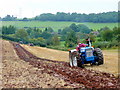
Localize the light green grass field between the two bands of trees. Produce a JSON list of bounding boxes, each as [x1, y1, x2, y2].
[[0, 21, 118, 31]]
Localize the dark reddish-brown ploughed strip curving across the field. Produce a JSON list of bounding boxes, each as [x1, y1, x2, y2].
[[11, 42, 120, 88]]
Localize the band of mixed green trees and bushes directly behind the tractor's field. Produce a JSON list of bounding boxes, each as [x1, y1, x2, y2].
[[1, 23, 120, 49]]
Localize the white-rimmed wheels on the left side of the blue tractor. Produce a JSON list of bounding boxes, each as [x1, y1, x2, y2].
[[69, 51, 83, 67]]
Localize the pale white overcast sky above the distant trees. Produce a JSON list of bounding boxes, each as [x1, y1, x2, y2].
[[0, 0, 119, 18]]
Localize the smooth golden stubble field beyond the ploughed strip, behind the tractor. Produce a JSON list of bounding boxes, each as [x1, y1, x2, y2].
[[22, 45, 119, 76]]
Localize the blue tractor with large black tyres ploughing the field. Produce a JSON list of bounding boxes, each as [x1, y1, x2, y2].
[[69, 41, 104, 67]]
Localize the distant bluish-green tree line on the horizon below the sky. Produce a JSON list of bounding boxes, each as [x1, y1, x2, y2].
[[0, 11, 118, 23]]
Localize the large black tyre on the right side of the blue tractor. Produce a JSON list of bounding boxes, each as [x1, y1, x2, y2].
[[93, 48, 104, 65]]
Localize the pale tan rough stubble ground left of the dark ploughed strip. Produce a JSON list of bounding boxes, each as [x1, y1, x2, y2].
[[0, 40, 72, 88]]
